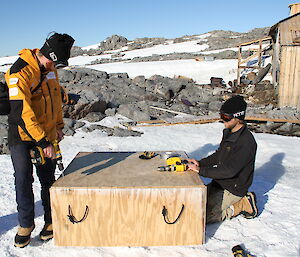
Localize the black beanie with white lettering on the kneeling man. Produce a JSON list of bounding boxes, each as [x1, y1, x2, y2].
[[220, 95, 247, 120]]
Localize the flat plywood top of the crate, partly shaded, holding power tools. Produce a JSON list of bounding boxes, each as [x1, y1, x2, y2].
[[52, 152, 204, 189]]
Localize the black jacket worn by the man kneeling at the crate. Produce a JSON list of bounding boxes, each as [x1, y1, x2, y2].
[[199, 125, 257, 196]]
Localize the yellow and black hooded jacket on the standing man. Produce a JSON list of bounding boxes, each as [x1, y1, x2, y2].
[[5, 49, 64, 148]]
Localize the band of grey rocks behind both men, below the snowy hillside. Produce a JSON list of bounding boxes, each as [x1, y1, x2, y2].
[[0, 65, 300, 153]]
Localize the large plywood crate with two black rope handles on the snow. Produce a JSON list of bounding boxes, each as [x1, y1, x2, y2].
[[50, 152, 206, 246]]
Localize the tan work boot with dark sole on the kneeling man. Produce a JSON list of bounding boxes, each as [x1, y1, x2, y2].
[[233, 192, 258, 219]]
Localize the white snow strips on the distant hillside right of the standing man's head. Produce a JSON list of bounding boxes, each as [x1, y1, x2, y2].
[[69, 34, 237, 84]]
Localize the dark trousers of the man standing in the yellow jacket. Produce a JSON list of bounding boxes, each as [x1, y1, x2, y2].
[[10, 144, 55, 228]]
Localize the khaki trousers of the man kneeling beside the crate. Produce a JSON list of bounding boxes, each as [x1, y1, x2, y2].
[[206, 183, 242, 224]]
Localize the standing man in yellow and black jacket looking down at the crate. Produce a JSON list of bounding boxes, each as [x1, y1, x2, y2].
[[5, 33, 74, 247]]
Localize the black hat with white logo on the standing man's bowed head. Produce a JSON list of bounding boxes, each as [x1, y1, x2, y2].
[[40, 33, 75, 67]]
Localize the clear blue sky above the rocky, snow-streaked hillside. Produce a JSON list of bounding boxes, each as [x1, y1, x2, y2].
[[0, 0, 297, 56]]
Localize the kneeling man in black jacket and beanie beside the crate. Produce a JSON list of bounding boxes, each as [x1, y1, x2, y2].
[[188, 95, 258, 223]]
